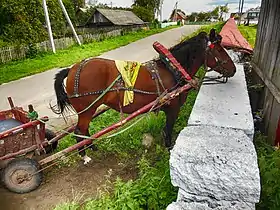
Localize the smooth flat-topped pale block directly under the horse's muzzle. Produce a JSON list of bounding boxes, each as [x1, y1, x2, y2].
[[188, 64, 254, 140]]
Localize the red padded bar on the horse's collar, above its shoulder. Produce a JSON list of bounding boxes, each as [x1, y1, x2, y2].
[[153, 42, 192, 81]]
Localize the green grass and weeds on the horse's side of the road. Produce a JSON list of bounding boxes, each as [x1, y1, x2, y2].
[[52, 24, 224, 210]]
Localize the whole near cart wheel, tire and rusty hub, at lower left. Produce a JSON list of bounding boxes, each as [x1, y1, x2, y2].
[[2, 158, 43, 193]]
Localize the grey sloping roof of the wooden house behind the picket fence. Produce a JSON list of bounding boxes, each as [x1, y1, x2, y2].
[[95, 8, 144, 25]]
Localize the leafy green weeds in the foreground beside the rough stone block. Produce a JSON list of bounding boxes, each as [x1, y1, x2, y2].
[[80, 146, 177, 210]]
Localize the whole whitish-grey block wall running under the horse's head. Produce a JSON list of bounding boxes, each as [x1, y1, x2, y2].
[[167, 55, 260, 210]]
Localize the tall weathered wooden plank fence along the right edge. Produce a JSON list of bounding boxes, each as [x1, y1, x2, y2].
[[252, 0, 280, 144]]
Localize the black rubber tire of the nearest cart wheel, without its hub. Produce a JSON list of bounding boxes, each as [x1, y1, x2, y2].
[[2, 158, 43, 194]]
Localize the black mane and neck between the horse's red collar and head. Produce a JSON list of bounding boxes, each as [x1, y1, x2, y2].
[[169, 32, 208, 73]]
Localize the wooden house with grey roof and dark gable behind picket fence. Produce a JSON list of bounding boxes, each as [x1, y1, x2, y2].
[[83, 8, 144, 27]]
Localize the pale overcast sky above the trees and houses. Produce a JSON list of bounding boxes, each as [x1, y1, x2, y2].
[[98, 0, 261, 19]]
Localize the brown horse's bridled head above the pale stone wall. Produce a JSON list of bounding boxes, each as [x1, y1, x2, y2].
[[205, 28, 236, 78]]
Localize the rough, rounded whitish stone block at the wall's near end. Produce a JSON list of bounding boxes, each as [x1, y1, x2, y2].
[[170, 125, 260, 206]]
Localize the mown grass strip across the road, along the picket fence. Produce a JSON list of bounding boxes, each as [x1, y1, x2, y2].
[[0, 26, 177, 84]]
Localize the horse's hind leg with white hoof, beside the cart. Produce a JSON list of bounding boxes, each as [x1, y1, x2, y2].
[[74, 112, 94, 164]]
